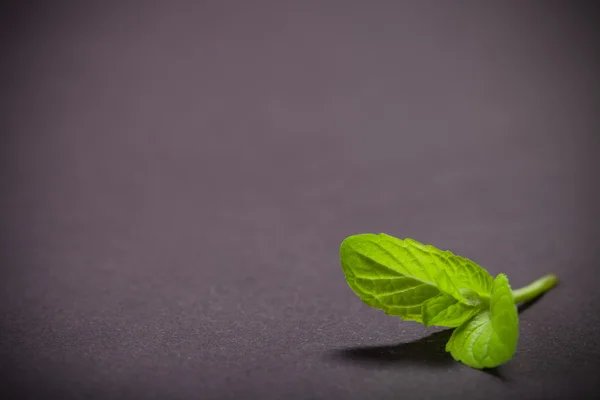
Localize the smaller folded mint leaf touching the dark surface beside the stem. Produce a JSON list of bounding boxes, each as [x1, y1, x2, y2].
[[446, 274, 519, 369]]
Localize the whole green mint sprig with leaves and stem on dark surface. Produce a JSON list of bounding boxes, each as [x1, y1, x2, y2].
[[340, 233, 558, 369]]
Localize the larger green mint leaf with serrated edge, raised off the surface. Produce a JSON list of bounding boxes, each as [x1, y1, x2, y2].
[[340, 234, 493, 326]]
